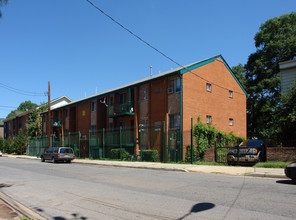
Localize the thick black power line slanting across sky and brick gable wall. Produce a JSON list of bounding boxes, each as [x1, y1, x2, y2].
[[86, 0, 245, 95]]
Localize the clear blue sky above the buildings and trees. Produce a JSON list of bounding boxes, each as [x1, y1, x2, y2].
[[0, 0, 296, 118]]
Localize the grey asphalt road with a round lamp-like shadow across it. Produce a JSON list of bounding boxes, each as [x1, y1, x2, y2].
[[0, 157, 296, 220]]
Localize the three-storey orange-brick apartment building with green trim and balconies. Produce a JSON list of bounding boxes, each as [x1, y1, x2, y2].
[[43, 55, 247, 162]]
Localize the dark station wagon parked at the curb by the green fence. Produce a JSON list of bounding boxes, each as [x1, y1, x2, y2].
[[40, 147, 75, 163]]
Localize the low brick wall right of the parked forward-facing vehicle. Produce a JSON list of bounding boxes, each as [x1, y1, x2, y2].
[[266, 147, 296, 162]]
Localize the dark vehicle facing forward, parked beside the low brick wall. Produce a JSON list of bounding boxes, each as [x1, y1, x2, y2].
[[227, 139, 275, 165]]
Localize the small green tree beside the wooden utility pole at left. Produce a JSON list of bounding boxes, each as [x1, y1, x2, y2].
[[26, 104, 48, 137]]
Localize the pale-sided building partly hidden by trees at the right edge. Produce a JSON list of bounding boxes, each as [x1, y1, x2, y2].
[[279, 59, 296, 93]]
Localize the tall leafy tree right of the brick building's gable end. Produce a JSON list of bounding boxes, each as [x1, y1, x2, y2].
[[245, 12, 296, 138]]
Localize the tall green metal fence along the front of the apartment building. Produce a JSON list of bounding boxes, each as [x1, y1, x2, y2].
[[28, 122, 204, 162]]
